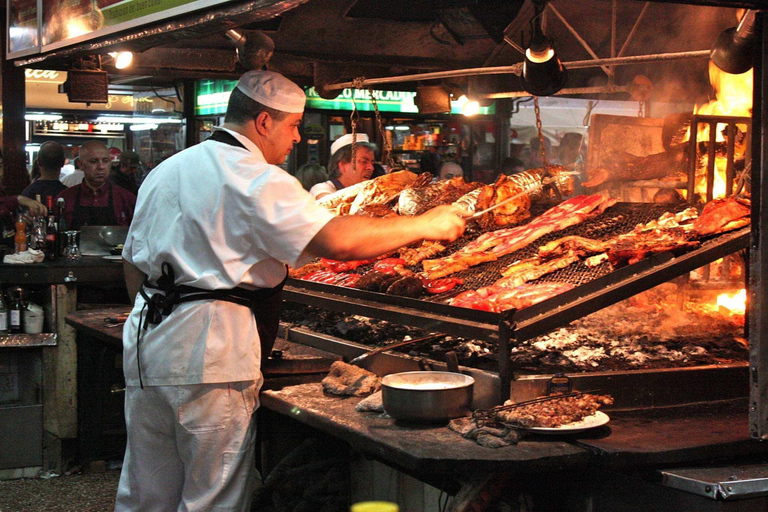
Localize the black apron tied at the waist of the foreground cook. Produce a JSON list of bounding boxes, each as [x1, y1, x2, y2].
[[136, 262, 288, 388]]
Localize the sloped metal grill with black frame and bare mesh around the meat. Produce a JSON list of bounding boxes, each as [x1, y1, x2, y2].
[[284, 203, 749, 399]]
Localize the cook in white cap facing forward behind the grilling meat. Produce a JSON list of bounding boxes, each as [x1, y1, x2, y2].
[[309, 133, 376, 199]]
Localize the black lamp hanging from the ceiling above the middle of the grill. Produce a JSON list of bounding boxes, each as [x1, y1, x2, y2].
[[521, 0, 567, 96]]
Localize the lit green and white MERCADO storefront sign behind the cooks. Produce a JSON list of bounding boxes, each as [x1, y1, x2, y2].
[[195, 80, 496, 115]]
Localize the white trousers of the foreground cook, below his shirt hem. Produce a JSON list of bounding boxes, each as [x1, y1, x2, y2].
[[115, 381, 260, 512]]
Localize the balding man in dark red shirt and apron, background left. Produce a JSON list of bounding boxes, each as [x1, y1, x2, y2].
[[56, 140, 136, 229]]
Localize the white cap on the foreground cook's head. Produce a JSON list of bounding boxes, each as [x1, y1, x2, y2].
[[237, 70, 307, 114]]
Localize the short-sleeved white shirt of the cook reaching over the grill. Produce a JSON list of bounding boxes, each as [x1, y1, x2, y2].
[[123, 130, 333, 386]]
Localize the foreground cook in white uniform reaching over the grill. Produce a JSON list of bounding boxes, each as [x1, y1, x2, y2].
[[115, 71, 466, 511]]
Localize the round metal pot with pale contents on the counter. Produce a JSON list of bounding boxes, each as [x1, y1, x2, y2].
[[381, 372, 475, 422]]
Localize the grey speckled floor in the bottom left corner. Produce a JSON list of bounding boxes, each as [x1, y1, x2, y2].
[[0, 470, 120, 512]]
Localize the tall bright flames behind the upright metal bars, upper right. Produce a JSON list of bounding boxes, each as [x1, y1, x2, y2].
[[693, 61, 753, 198]]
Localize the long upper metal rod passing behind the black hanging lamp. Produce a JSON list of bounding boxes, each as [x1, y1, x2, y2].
[[325, 50, 709, 91]]
